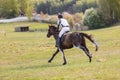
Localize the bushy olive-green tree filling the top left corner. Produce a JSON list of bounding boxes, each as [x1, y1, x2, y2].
[[0, 0, 19, 18]]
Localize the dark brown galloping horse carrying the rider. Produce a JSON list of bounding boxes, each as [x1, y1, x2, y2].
[[47, 25, 98, 65]]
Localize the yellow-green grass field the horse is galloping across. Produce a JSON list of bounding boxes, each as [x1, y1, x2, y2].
[[0, 22, 120, 80]]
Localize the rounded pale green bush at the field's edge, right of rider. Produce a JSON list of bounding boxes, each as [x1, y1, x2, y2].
[[83, 8, 105, 29]]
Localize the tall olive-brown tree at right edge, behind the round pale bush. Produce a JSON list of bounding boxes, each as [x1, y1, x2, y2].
[[98, 0, 120, 25]]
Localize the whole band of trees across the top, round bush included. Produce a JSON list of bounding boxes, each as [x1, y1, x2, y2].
[[0, 0, 120, 29]]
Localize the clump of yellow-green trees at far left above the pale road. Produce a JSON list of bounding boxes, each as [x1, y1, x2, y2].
[[0, 0, 32, 18]]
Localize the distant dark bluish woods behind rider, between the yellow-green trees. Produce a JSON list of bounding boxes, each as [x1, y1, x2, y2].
[[35, 0, 98, 14]]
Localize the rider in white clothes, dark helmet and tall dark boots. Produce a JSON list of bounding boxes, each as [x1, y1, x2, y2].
[[56, 13, 70, 47]]
